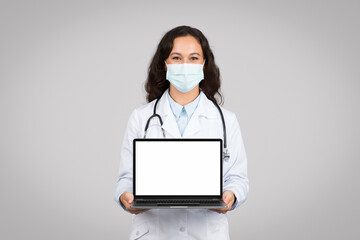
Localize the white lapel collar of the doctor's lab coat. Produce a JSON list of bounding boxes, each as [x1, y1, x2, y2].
[[156, 89, 220, 138]]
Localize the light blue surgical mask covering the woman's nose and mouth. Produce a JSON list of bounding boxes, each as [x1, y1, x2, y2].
[[165, 61, 205, 93]]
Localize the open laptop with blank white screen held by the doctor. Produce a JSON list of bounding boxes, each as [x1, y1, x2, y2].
[[131, 138, 226, 209]]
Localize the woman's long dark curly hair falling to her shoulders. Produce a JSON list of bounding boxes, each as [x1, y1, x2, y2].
[[145, 26, 223, 104]]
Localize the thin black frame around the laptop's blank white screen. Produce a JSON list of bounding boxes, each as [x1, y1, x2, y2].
[[133, 138, 223, 200]]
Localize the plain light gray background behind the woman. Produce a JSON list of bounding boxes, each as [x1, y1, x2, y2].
[[0, 0, 360, 239]]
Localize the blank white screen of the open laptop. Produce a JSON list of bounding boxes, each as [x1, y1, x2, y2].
[[135, 140, 221, 196]]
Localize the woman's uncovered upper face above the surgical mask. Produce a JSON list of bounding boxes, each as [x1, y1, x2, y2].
[[165, 36, 204, 64]]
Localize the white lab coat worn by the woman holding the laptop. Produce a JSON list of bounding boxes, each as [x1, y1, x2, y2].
[[115, 90, 249, 240]]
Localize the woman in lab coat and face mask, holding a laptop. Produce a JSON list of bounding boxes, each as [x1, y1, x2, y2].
[[115, 26, 249, 240]]
